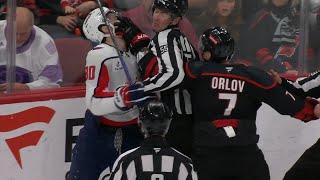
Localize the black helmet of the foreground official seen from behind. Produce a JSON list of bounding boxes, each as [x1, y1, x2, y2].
[[138, 100, 172, 137]]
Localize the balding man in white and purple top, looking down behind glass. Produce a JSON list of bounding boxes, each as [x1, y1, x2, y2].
[[0, 7, 62, 91]]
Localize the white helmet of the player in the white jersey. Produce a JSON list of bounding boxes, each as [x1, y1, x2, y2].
[[82, 7, 116, 43]]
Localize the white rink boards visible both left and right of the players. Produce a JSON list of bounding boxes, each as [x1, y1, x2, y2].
[[0, 89, 320, 180]]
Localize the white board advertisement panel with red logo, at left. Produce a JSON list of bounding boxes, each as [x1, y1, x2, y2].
[[0, 98, 85, 180]]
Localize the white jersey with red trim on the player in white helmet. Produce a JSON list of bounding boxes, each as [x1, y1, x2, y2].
[[85, 44, 139, 127]]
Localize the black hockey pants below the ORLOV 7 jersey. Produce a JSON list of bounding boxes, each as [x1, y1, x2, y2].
[[193, 145, 270, 180]]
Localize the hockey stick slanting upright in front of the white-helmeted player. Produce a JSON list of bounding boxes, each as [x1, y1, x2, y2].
[[96, 0, 133, 84]]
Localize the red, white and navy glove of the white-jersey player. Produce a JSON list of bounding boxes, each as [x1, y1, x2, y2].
[[114, 82, 154, 110]]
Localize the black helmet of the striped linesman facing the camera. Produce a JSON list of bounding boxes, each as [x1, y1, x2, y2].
[[152, 0, 188, 17]]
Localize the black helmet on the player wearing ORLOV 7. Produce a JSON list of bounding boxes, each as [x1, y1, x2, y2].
[[199, 27, 234, 63]]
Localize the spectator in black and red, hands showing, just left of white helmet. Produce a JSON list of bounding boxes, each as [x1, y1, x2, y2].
[[36, 0, 98, 38]]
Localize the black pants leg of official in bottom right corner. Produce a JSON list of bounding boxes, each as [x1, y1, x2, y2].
[[283, 139, 320, 180]]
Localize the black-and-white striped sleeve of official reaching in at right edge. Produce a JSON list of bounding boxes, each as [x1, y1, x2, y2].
[[282, 71, 320, 98]]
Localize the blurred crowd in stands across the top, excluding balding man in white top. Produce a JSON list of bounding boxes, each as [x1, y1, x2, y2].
[[0, 0, 320, 92]]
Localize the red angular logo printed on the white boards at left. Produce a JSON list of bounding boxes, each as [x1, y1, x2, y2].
[[0, 106, 55, 169]]
